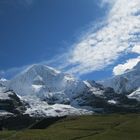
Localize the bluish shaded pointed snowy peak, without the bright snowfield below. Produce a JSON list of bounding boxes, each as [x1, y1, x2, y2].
[[7, 65, 86, 104]]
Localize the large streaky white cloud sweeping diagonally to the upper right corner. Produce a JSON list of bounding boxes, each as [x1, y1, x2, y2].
[[56, 0, 140, 75]]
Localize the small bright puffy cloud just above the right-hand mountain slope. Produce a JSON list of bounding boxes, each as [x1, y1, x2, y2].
[[113, 57, 140, 75]]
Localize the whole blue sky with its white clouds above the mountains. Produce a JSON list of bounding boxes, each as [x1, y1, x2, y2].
[[0, 0, 140, 80]]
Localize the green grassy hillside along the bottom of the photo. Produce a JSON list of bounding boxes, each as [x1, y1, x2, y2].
[[0, 114, 140, 140]]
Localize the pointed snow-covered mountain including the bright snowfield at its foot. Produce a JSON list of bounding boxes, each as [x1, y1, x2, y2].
[[6, 65, 100, 116]]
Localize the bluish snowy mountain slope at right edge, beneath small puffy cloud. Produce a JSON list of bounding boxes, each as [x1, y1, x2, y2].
[[100, 62, 140, 94]]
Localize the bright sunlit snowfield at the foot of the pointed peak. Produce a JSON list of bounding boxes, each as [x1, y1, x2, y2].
[[22, 96, 93, 117]]
